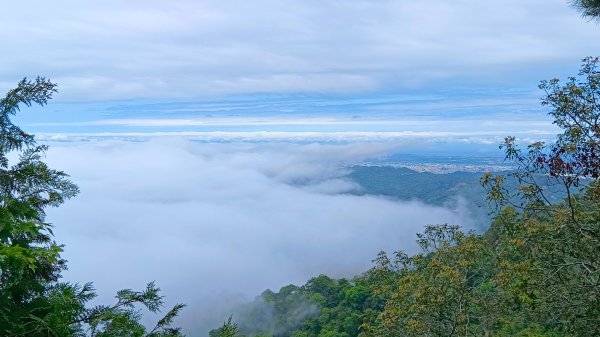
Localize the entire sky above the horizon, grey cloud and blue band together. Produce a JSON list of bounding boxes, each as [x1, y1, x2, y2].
[[0, 0, 600, 142]]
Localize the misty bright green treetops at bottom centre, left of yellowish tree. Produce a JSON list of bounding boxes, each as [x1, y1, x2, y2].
[[211, 275, 383, 337]]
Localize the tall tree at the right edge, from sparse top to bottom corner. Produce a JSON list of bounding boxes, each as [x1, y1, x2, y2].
[[482, 57, 600, 336]]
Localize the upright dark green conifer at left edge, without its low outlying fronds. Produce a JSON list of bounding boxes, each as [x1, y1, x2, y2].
[[0, 78, 80, 335]]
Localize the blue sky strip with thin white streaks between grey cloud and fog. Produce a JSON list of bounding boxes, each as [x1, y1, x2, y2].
[[18, 90, 557, 154]]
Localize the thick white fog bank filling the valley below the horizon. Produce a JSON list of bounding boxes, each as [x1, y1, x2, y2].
[[42, 139, 470, 336]]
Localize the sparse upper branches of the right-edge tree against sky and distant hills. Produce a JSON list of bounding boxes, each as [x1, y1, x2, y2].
[[482, 57, 600, 211]]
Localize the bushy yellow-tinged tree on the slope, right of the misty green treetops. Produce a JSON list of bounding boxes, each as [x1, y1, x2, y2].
[[368, 225, 500, 337]]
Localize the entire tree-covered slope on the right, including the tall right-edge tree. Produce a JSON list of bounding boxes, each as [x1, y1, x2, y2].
[[220, 58, 600, 337]]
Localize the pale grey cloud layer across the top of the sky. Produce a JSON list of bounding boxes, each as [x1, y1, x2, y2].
[[0, 0, 600, 100]]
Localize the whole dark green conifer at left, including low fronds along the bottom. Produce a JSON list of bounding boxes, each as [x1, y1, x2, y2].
[[0, 78, 183, 337]]
